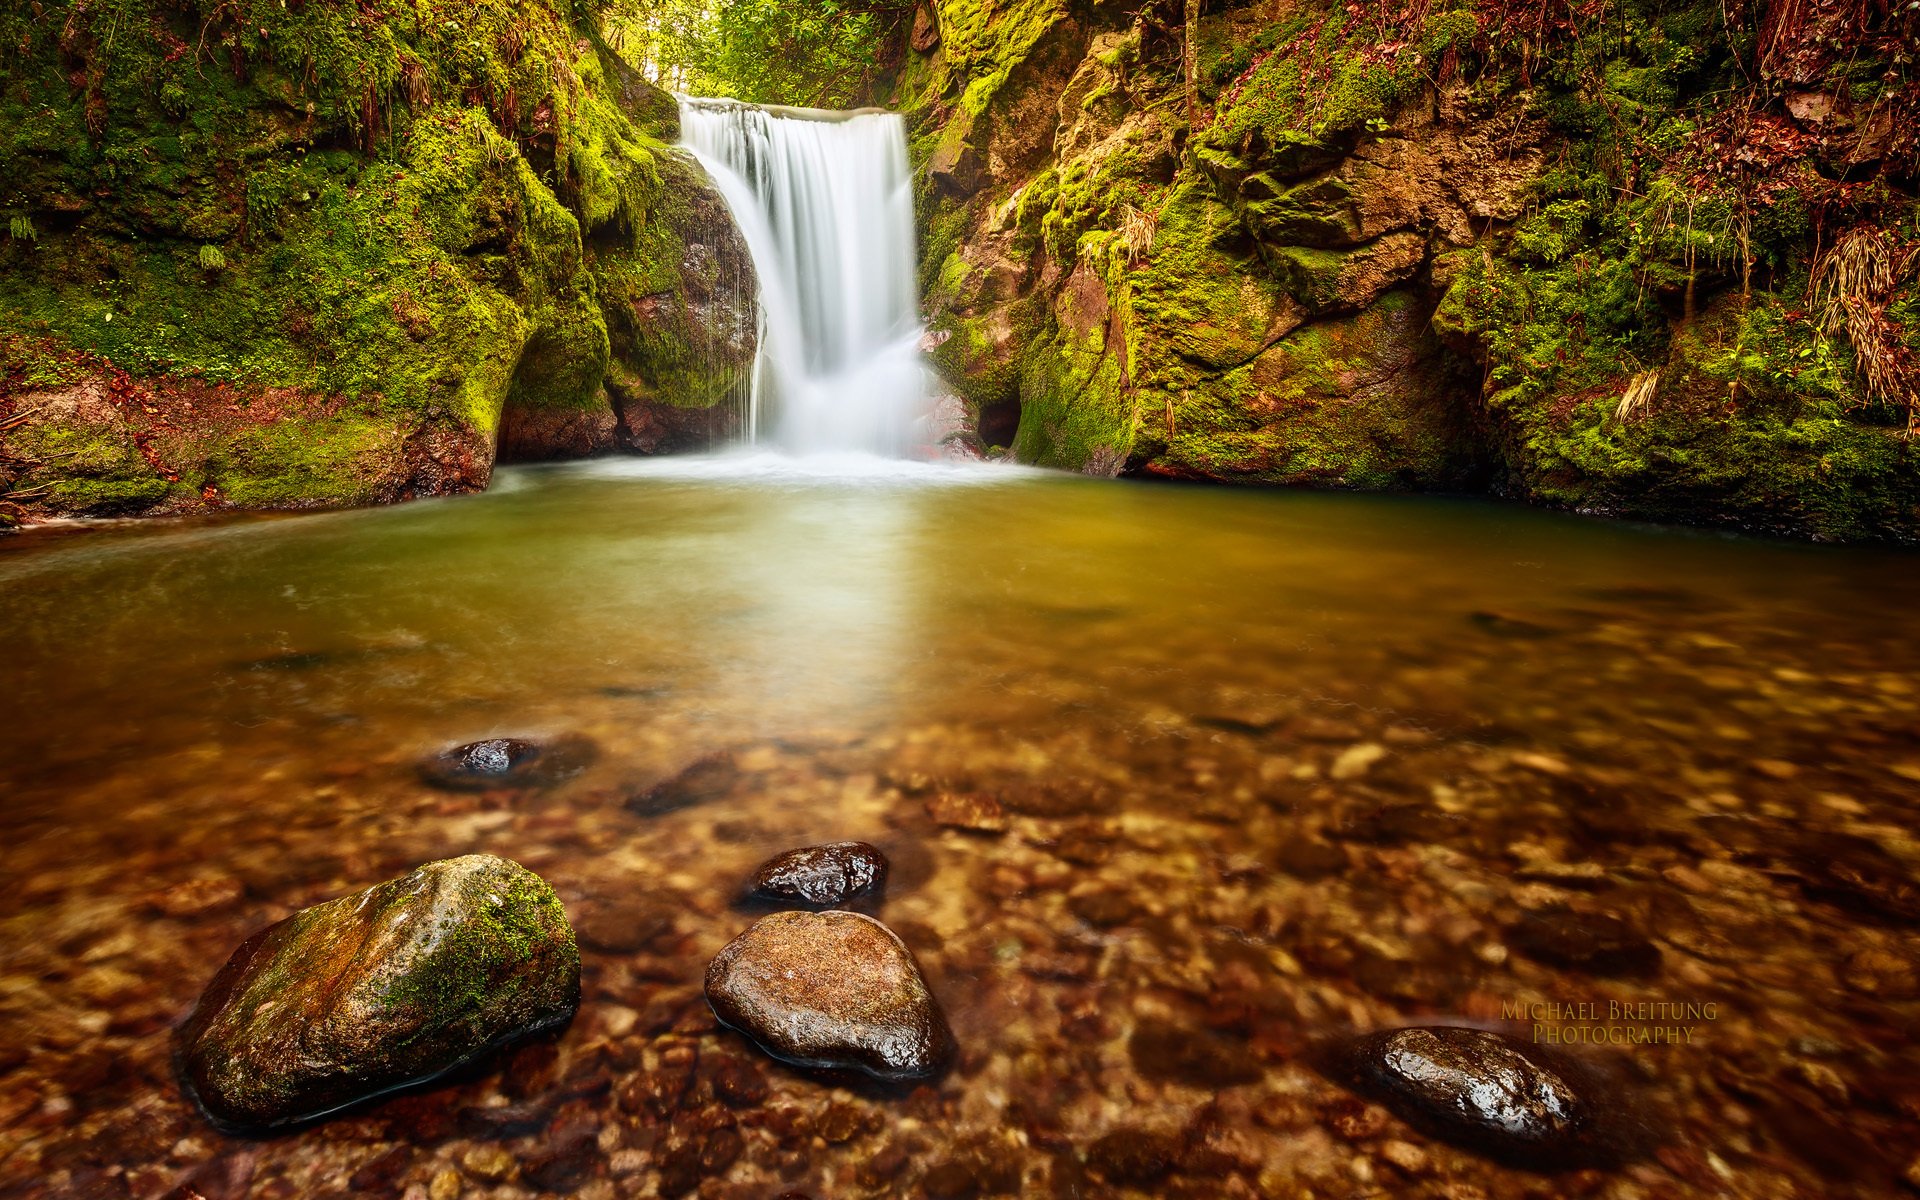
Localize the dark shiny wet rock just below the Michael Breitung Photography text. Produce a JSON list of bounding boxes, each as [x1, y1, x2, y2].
[[1348, 1025, 1594, 1167]]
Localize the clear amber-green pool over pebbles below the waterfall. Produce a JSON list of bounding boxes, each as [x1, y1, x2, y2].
[[0, 457, 1920, 1200]]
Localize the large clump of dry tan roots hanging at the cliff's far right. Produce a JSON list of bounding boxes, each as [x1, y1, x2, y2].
[[1809, 225, 1920, 436]]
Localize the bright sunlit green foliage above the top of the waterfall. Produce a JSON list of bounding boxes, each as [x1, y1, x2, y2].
[[607, 0, 914, 108]]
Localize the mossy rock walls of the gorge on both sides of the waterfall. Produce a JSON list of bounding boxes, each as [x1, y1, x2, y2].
[[0, 0, 1920, 541]]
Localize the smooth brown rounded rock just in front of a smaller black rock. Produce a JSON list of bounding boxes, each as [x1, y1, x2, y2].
[[707, 910, 954, 1079]]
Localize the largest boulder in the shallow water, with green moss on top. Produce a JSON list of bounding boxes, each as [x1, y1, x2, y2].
[[177, 854, 580, 1129]]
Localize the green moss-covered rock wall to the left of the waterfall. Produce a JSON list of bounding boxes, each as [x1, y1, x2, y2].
[[0, 0, 755, 513]]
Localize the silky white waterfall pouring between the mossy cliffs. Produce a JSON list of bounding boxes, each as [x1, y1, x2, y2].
[[680, 98, 927, 455]]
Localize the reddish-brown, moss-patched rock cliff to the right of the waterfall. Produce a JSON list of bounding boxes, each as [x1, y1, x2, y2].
[[899, 0, 1920, 540]]
